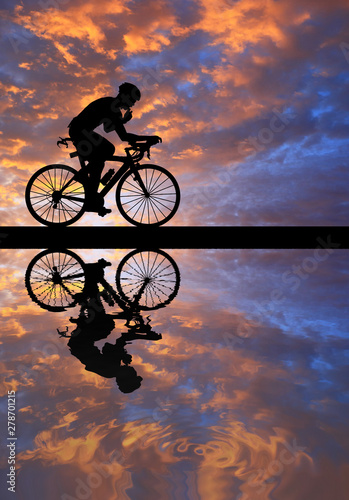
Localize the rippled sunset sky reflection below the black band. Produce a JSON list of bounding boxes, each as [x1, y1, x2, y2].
[[0, 249, 349, 500]]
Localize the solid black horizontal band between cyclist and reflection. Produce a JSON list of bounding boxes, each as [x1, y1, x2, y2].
[[0, 226, 349, 249]]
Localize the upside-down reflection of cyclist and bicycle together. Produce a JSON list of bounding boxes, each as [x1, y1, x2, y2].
[[25, 249, 180, 392]]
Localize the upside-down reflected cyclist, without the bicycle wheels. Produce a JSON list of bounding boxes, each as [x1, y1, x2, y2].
[[64, 259, 162, 393]]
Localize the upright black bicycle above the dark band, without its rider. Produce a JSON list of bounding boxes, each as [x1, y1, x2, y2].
[[25, 138, 180, 226]]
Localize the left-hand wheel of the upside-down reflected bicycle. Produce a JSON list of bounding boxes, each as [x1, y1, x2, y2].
[[25, 250, 85, 311]]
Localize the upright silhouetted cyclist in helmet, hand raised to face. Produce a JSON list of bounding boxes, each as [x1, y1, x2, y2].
[[68, 82, 161, 217]]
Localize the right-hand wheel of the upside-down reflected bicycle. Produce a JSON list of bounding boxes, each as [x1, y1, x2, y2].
[[116, 250, 180, 310]]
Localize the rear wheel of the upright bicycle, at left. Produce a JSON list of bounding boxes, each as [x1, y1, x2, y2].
[[25, 165, 85, 226]]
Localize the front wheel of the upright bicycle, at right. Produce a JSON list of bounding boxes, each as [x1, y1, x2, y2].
[[116, 165, 180, 226]]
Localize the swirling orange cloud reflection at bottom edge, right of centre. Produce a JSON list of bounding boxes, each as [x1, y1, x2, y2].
[[194, 420, 313, 500]]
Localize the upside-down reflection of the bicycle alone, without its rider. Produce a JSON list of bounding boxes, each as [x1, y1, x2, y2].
[[25, 250, 180, 312]]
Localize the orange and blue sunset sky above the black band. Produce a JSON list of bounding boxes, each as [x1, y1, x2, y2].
[[0, 0, 349, 226]]
